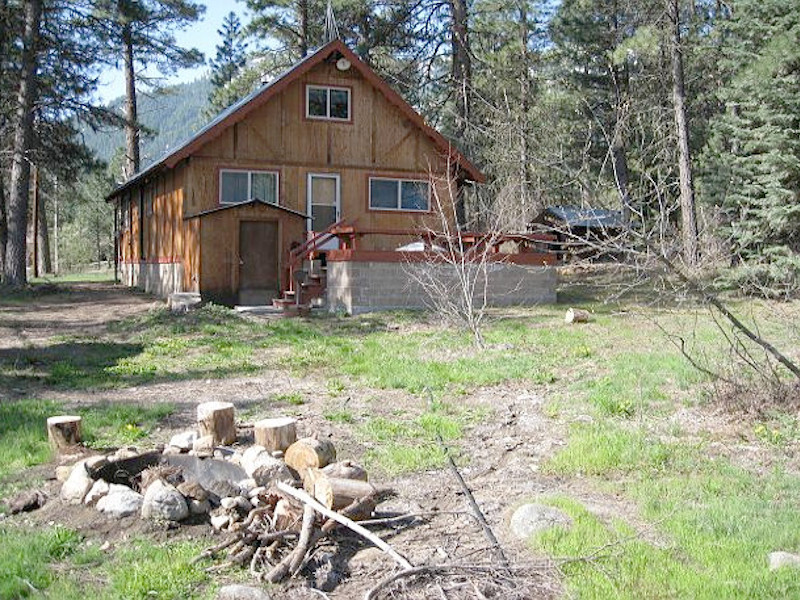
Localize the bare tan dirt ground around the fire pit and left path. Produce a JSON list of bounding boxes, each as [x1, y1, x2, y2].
[[0, 285, 580, 598]]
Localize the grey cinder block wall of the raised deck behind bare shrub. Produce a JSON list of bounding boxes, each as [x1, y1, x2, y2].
[[327, 261, 557, 314]]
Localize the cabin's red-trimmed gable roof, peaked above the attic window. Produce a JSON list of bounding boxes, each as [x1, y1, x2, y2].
[[106, 40, 486, 200]]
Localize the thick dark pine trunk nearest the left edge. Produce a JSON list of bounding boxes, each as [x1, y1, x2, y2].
[[3, 0, 42, 285]]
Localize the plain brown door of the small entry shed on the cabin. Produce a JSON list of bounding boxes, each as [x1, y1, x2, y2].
[[239, 221, 280, 305]]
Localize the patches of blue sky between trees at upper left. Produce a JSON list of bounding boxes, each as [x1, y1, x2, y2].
[[97, 0, 249, 101]]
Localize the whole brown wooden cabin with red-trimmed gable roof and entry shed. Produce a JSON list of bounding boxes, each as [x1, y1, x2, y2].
[[108, 40, 484, 304]]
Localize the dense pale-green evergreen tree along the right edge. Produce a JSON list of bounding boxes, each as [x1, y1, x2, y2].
[[704, 0, 800, 294]]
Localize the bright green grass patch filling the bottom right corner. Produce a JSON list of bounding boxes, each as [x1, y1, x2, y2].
[[535, 424, 800, 600]]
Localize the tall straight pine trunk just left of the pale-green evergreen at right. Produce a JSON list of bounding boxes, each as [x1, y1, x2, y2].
[[668, 0, 698, 265]]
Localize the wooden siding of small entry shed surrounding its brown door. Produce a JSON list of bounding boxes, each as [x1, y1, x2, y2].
[[195, 204, 305, 304]]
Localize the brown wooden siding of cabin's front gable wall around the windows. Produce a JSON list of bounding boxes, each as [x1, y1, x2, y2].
[[186, 62, 455, 250]]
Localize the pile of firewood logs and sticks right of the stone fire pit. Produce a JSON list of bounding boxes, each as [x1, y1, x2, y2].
[[198, 437, 394, 583]]
